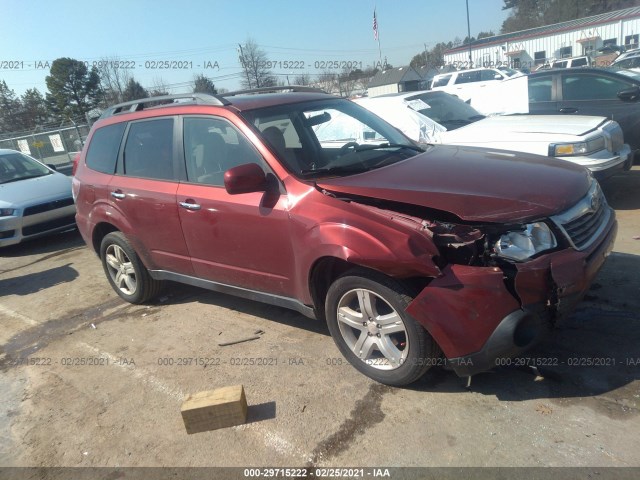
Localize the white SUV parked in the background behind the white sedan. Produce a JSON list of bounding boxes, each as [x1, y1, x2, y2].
[[431, 68, 518, 101]]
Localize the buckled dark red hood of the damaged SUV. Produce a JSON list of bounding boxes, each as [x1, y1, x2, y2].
[[317, 145, 591, 223]]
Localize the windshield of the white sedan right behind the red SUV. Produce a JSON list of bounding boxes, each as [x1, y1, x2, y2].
[[406, 92, 484, 130]]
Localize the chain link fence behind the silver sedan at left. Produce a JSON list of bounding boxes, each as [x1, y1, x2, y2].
[[0, 125, 90, 167]]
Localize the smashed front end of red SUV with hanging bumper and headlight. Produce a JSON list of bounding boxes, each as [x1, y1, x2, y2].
[[407, 182, 617, 376]]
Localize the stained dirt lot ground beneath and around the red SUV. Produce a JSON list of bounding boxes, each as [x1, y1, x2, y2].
[[0, 166, 640, 474]]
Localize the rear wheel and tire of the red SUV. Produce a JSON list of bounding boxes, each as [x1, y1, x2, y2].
[[100, 232, 162, 304]]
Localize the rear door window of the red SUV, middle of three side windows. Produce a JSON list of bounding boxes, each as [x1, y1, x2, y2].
[[123, 118, 175, 180]]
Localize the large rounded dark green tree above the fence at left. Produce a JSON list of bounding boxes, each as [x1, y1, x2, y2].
[[45, 58, 102, 117]]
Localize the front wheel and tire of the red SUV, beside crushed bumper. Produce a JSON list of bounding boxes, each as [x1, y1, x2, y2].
[[325, 270, 440, 386]]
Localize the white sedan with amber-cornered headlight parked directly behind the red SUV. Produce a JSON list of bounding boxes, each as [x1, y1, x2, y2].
[[355, 91, 633, 180]]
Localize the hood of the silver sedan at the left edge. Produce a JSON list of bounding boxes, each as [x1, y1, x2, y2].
[[0, 173, 71, 207]]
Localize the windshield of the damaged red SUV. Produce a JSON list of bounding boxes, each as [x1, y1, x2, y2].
[[243, 99, 422, 178]]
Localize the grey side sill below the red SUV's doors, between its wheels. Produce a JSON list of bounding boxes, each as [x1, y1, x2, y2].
[[149, 270, 316, 319]]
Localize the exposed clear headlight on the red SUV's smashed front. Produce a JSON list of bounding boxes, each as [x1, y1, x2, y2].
[[494, 222, 557, 261]]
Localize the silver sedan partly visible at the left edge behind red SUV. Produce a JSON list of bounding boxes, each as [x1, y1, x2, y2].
[[0, 149, 76, 247]]
